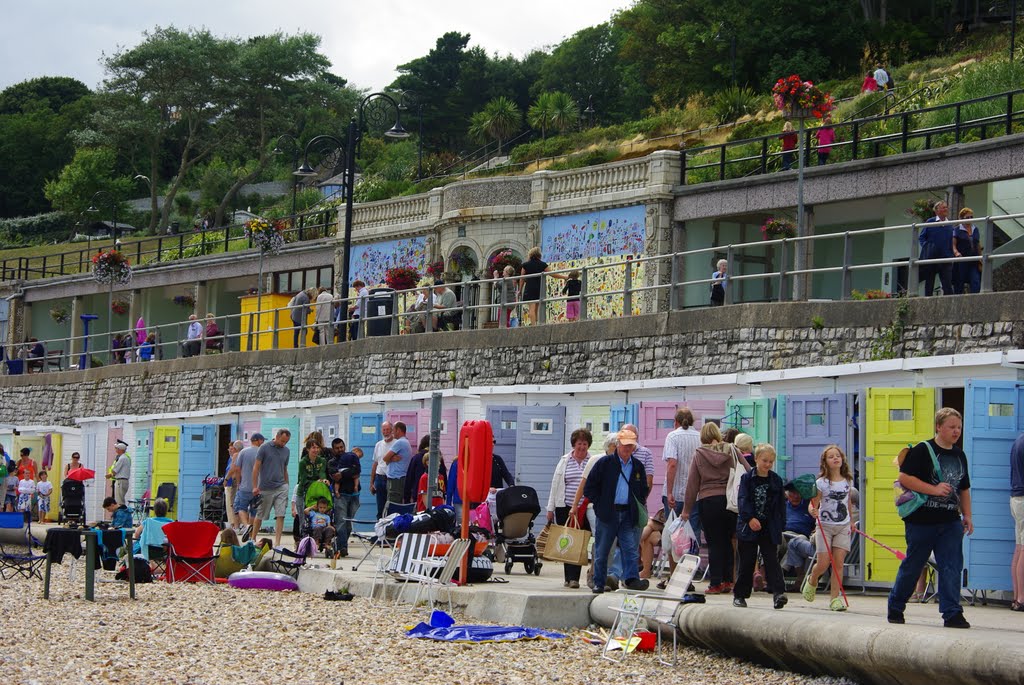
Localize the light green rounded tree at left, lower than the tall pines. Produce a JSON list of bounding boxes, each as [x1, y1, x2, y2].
[[44, 147, 132, 219]]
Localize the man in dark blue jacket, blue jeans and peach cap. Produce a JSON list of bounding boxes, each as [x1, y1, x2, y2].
[[584, 429, 649, 594]]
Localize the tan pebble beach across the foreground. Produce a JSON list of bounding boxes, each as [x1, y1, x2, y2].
[[0, 564, 864, 685]]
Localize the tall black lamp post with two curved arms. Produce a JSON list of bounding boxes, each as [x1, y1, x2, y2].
[[295, 92, 410, 339]]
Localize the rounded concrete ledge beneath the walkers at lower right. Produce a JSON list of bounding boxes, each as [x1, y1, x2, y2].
[[591, 593, 1024, 685]]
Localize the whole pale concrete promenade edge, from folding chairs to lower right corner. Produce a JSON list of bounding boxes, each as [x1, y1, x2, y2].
[[299, 547, 1024, 685]]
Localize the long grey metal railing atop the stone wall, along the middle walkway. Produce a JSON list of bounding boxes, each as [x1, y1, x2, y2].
[[4, 213, 1024, 373]]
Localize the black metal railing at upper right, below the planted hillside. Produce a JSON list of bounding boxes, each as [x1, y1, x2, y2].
[[680, 89, 1024, 185]]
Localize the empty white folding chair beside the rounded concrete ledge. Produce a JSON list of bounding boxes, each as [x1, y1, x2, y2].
[[601, 554, 700, 666]]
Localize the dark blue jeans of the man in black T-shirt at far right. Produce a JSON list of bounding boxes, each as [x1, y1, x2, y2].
[[889, 519, 964, 620]]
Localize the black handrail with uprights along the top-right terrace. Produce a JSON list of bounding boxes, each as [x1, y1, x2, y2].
[[680, 89, 1024, 185]]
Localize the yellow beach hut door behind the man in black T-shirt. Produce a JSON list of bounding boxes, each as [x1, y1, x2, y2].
[[861, 388, 935, 583]]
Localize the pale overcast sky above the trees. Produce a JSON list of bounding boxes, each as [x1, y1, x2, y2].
[[0, 0, 633, 89]]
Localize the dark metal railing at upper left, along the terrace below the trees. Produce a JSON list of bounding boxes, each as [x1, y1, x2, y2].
[[0, 208, 337, 281]]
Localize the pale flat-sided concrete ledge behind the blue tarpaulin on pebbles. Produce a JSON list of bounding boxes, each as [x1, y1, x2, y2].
[[299, 562, 591, 629]]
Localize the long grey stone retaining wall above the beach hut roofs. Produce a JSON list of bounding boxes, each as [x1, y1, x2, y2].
[[0, 293, 1024, 425]]
